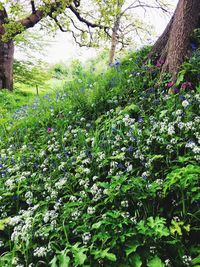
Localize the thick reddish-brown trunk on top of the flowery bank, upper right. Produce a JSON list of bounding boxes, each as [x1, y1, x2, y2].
[[149, 0, 200, 82]]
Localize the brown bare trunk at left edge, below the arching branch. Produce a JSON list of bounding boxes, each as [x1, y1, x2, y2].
[[0, 41, 14, 90]]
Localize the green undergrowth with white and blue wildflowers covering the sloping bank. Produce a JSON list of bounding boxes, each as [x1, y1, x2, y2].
[[0, 49, 200, 267]]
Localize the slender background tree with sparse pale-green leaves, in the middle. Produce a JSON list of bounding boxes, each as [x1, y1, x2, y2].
[[96, 0, 170, 64]]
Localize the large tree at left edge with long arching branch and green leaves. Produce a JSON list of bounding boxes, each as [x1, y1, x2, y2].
[[0, 0, 107, 90]]
